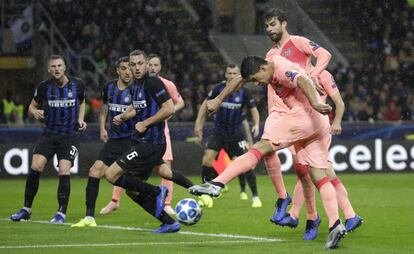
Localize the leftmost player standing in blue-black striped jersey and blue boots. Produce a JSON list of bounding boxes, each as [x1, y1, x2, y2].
[[10, 55, 86, 224]]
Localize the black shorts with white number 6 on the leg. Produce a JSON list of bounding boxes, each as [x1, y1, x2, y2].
[[116, 141, 166, 180]]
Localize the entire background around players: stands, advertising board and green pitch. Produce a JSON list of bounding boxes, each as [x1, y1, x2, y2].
[[0, 0, 414, 254]]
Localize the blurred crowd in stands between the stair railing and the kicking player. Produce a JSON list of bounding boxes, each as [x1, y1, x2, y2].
[[45, 0, 223, 121]]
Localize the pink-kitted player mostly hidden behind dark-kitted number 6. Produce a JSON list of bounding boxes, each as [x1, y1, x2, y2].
[[100, 54, 184, 215]]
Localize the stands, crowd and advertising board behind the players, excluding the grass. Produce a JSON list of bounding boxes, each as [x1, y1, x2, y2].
[[0, 0, 414, 177]]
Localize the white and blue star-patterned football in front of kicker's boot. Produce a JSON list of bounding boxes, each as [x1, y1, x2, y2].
[[175, 198, 203, 225]]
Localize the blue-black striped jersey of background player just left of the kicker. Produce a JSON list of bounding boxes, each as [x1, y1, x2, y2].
[[208, 81, 256, 135]]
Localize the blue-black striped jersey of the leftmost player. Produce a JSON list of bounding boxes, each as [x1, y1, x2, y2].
[[33, 76, 85, 135]]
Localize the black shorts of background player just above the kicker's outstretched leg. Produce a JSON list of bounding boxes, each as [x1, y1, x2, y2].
[[206, 133, 247, 158]]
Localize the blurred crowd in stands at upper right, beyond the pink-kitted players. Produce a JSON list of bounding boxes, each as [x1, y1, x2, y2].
[[334, 0, 414, 121]]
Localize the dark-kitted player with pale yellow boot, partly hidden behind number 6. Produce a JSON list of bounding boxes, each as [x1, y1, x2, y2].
[[72, 57, 134, 227]]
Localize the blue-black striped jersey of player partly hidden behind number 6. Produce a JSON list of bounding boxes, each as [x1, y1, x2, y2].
[[102, 80, 135, 139]]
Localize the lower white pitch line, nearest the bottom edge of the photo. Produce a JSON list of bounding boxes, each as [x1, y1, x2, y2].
[[0, 240, 274, 249]]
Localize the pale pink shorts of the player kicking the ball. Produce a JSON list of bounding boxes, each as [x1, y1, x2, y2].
[[262, 109, 331, 168]]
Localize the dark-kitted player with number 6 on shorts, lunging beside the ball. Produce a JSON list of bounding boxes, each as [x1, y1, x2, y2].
[[105, 50, 186, 233]]
